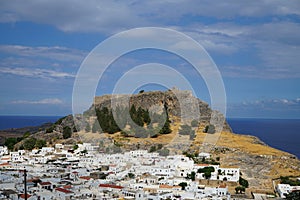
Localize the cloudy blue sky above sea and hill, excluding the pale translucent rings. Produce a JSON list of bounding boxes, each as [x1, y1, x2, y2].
[[0, 0, 300, 118]]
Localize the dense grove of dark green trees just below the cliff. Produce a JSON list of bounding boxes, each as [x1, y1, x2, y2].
[[94, 105, 172, 138]]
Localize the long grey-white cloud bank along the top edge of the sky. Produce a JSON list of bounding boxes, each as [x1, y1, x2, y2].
[[0, 0, 300, 33]]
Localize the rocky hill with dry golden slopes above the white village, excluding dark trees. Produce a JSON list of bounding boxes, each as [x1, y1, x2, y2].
[[4, 90, 300, 193]]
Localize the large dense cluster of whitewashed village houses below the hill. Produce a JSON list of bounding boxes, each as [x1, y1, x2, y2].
[[0, 143, 240, 200]]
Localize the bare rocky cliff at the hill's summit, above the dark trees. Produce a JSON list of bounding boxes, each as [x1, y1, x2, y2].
[[90, 89, 231, 132]]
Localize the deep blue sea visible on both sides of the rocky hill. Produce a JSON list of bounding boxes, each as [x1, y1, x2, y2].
[[0, 116, 300, 158]]
